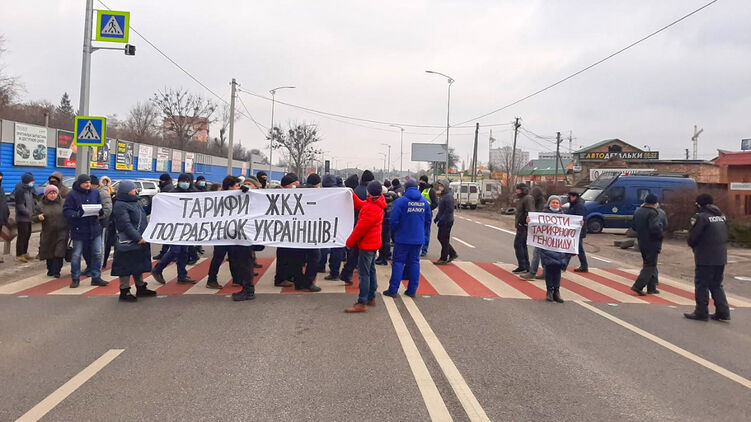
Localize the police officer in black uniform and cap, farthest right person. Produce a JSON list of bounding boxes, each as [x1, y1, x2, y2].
[[683, 193, 730, 321]]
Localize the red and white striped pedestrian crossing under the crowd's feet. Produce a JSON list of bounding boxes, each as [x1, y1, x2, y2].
[[0, 258, 751, 307]]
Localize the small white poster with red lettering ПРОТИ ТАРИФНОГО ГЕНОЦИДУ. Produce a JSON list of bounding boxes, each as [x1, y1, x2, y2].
[[527, 212, 583, 254]]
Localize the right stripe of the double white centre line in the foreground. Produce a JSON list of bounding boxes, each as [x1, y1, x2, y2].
[[404, 297, 490, 421]]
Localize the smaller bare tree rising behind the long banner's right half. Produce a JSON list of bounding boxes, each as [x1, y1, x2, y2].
[[271, 122, 321, 175]]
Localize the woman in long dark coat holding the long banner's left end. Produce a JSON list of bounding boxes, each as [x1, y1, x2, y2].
[[111, 180, 156, 302]]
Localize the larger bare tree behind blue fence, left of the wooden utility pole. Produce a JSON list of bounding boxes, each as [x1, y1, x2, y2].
[[151, 88, 216, 147]]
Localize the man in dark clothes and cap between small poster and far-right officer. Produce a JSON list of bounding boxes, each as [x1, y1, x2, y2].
[[631, 193, 664, 296]]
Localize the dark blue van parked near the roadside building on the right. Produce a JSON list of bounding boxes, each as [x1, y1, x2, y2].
[[581, 173, 696, 233]]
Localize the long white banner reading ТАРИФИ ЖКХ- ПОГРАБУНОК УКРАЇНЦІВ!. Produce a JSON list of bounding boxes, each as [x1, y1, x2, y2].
[[143, 188, 355, 249]]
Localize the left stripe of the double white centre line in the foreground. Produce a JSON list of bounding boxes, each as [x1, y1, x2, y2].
[[383, 296, 453, 421]]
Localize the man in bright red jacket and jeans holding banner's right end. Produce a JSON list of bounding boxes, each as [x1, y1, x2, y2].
[[344, 180, 386, 313]]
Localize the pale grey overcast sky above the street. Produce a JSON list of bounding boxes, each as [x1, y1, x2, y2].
[[0, 0, 751, 169]]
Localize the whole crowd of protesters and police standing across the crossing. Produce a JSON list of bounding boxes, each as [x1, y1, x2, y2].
[[0, 170, 730, 320]]
